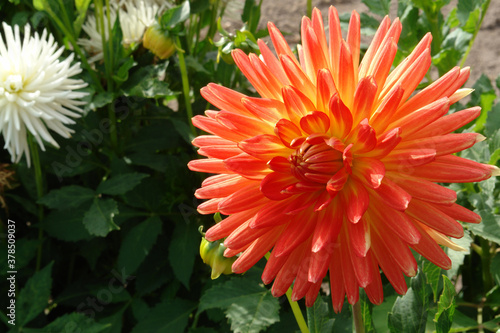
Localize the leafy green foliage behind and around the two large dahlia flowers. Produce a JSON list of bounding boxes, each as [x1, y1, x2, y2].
[[0, 0, 500, 333]]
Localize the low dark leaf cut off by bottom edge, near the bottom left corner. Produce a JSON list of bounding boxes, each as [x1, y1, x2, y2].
[[41, 312, 109, 333]]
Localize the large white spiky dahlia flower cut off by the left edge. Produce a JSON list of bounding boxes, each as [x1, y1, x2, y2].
[[0, 23, 87, 165]]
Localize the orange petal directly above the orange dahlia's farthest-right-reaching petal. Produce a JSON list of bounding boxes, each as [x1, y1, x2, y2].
[[398, 133, 486, 156]]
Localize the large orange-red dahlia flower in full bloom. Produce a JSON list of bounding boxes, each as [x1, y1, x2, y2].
[[189, 7, 499, 311]]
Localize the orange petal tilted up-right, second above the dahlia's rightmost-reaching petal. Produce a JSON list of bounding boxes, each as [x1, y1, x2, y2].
[[407, 106, 481, 140]]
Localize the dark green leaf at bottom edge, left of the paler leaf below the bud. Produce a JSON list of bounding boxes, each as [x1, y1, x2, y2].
[[132, 299, 196, 333]]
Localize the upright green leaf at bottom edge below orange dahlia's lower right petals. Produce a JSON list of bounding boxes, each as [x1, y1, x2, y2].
[[389, 272, 430, 332]]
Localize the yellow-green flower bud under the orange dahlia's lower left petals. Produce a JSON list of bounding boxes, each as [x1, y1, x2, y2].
[[200, 237, 236, 280]]
